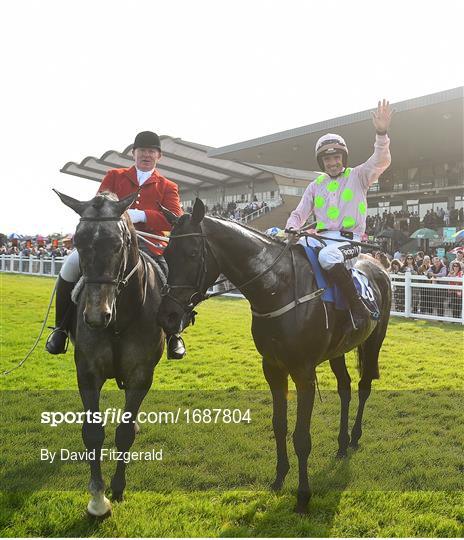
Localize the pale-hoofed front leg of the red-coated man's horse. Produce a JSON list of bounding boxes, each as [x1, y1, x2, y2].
[[78, 378, 111, 517]]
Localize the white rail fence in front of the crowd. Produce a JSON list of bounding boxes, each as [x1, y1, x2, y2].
[[0, 255, 464, 324]]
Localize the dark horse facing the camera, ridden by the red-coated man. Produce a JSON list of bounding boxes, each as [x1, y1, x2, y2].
[[57, 192, 164, 516]]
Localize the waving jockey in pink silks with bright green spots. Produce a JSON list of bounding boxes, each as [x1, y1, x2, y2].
[[286, 100, 393, 329]]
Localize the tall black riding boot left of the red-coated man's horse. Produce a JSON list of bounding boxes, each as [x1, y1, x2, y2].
[[45, 276, 75, 354]]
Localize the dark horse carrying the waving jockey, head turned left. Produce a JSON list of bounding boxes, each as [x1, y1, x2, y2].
[[159, 199, 391, 512]]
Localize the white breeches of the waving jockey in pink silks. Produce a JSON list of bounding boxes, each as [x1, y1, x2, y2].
[[298, 231, 361, 270]]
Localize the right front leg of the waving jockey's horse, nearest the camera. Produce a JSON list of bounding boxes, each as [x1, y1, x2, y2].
[[292, 373, 315, 514]]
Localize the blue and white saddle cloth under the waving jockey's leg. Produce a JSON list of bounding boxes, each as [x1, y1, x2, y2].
[[303, 246, 380, 320]]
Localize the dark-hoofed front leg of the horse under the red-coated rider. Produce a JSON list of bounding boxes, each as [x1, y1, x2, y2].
[[111, 380, 151, 501]]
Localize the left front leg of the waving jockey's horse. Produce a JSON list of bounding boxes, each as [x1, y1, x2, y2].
[[263, 358, 290, 490]]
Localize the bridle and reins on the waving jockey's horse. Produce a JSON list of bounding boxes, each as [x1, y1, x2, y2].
[[161, 226, 291, 313]]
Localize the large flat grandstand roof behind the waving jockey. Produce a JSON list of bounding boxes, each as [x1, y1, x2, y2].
[[208, 86, 464, 170]]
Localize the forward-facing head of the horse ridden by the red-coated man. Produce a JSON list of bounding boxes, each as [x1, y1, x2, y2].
[[55, 190, 137, 328]]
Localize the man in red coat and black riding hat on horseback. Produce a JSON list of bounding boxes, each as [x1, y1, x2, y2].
[[46, 131, 185, 359]]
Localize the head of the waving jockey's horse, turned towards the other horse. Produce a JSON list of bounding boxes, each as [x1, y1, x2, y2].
[[158, 199, 219, 334]]
